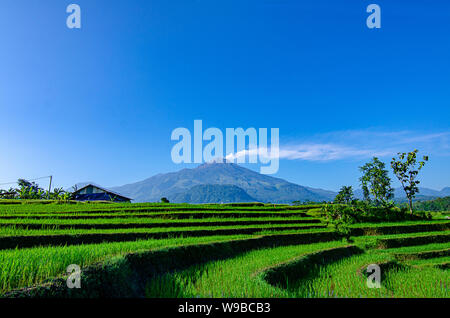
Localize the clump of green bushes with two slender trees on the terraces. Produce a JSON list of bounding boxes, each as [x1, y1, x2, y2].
[[322, 149, 432, 235]]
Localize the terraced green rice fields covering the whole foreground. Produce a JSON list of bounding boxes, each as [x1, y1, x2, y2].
[[0, 200, 450, 298]]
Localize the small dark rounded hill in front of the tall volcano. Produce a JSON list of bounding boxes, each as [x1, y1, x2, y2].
[[169, 184, 257, 203]]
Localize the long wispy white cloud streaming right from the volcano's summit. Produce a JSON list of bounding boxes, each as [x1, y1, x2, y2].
[[226, 130, 450, 161]]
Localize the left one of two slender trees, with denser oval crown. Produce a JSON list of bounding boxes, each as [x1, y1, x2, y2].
[[359, 157, 394, 206]]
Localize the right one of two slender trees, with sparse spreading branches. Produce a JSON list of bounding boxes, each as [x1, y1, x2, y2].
[[391, 149, 428, 215]]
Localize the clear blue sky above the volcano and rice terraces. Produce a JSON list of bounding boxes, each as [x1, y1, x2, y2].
[[0, 0, 450, 190]]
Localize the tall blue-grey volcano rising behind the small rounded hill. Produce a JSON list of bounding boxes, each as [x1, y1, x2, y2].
[[112, 163, 336, 203]]
